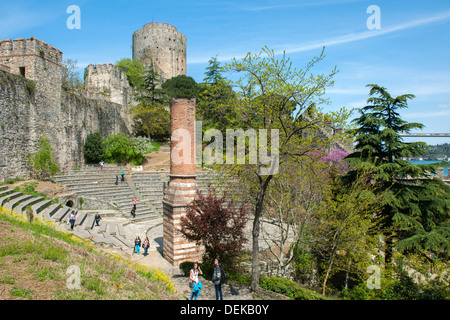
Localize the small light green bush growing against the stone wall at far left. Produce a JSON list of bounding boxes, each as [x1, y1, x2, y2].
[[28, 136, 60, 180]]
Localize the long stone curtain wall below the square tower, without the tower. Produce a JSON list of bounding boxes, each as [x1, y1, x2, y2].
[[0, 70, 127, 182]]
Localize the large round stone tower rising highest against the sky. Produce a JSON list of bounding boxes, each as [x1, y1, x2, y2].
[[133, 22, 186, 80]]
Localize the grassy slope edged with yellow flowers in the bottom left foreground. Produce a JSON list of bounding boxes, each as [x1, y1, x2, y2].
[[0, 208, 180, 300]]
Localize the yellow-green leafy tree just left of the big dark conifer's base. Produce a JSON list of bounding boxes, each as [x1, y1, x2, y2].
[[319, 172, 384, 295]]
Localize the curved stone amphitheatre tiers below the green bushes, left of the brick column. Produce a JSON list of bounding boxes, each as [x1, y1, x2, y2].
[[54, 164, 160, 221]]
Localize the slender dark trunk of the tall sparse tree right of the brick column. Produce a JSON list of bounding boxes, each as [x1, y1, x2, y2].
[[251, 175, 273, 292]]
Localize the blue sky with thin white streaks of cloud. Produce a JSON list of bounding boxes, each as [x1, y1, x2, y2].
[[0, 0, 450, 144]]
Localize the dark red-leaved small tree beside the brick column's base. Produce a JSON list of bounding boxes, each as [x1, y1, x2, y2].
[[181, 187, 248, 264]]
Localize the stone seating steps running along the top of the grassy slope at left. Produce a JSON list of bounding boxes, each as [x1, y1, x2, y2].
[[0, 186, 135, 250]]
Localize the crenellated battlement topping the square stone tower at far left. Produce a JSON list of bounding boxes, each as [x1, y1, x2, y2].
[[0, 37, 62, 65]]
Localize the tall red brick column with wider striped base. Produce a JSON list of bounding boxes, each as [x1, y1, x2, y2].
[[163, 99, 203, 266]]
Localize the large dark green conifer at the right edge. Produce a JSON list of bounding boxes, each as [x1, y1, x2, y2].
[[342, 84, 450, 266]]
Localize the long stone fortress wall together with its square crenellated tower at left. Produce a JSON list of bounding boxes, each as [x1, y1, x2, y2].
[[0, 37, 128, 182]]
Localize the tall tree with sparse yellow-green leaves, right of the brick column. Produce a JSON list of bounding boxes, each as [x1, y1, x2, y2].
[[215, 47, 337, 291]]
